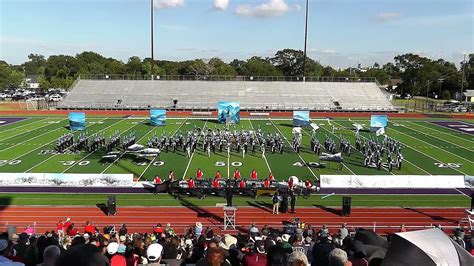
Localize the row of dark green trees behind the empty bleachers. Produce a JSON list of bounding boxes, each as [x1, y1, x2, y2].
[[0, 49, 474, 98]]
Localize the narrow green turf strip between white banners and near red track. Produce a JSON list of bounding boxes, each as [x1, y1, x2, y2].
[[0, 194, 470, 208]]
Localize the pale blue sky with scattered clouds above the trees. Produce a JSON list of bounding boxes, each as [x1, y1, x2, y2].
[[0, 0, 474, 68]]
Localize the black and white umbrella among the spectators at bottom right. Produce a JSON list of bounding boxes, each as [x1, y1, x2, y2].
[[382, 228, 474, 266]]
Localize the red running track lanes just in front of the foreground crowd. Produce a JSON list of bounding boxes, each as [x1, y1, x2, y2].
[[0, 206, 464, 234]]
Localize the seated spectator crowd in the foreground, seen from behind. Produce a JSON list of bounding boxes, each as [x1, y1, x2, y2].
[[0, 218, 474, 266]]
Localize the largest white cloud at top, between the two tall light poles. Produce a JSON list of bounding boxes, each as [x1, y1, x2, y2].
[[235, 0, 290, 17]]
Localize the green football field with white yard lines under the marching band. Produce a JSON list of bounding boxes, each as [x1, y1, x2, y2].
[[0, 116, 474, 180]]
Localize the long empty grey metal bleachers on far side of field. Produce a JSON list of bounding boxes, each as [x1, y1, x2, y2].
[[59, 79, 394, 112]]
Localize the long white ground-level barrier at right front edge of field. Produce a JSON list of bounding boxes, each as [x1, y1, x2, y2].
[[320, 175, 465, 188]]
